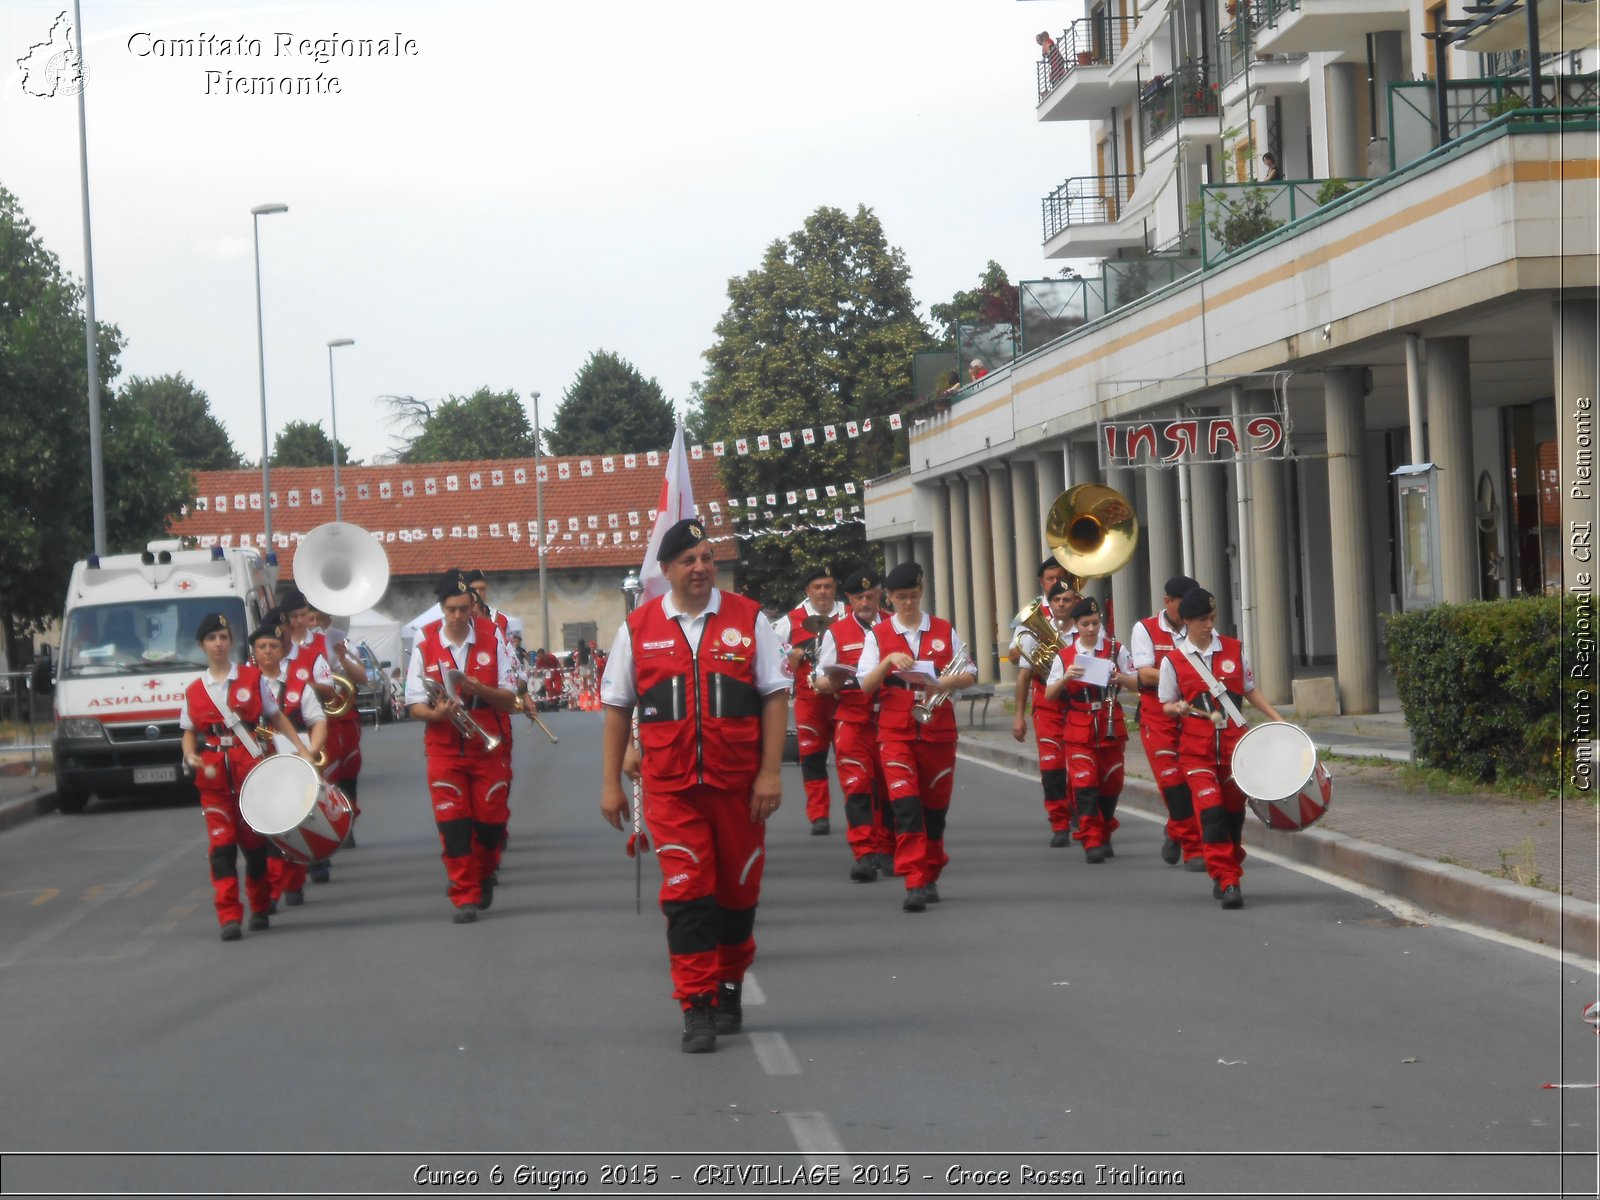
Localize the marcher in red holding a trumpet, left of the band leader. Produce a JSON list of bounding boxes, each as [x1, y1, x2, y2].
[[405, 566, 517, 925]]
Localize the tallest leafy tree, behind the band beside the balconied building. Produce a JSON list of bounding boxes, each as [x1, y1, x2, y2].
[[691, 206, 928, 606]]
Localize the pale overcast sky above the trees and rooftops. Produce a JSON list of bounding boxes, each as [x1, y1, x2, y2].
[[0, 0, 1091, 459]]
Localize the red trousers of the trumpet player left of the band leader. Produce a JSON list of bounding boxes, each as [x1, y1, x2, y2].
[[427, 750, 510, 909]]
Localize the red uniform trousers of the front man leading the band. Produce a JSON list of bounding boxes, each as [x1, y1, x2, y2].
[[645, 784, 766, 1008]]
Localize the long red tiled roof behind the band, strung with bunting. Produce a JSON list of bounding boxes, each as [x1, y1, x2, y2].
[[173, 451, 739, 578]]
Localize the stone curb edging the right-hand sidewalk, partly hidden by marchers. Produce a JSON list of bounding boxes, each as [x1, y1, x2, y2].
[[960, 739, 1600, 960]]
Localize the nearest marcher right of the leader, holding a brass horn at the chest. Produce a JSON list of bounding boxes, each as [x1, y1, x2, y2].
[[856, 562, 978, 912]]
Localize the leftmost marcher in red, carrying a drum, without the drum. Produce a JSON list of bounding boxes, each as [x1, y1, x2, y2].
[[178, 613, 312, 942]]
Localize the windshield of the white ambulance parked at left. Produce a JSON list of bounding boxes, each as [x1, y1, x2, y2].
[[61, 595, 246, 678]]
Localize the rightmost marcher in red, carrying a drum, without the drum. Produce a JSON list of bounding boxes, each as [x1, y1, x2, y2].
[[1157, 587, 1283, 909]]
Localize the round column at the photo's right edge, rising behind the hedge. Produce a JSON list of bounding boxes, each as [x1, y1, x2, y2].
[[1555, 296, 1600, 598]]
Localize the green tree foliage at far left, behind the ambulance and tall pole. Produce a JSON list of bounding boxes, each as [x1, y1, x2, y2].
[[0, 187, 190, 653]]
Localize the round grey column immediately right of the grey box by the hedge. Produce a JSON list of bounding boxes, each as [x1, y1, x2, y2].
[[1424, 338, 1478, 605]]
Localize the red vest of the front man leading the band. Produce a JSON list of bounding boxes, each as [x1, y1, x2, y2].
[[627, 592, 763, 792]]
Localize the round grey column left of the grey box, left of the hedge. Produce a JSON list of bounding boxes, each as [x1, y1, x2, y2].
[[1323, 366, 1378, 715]]
